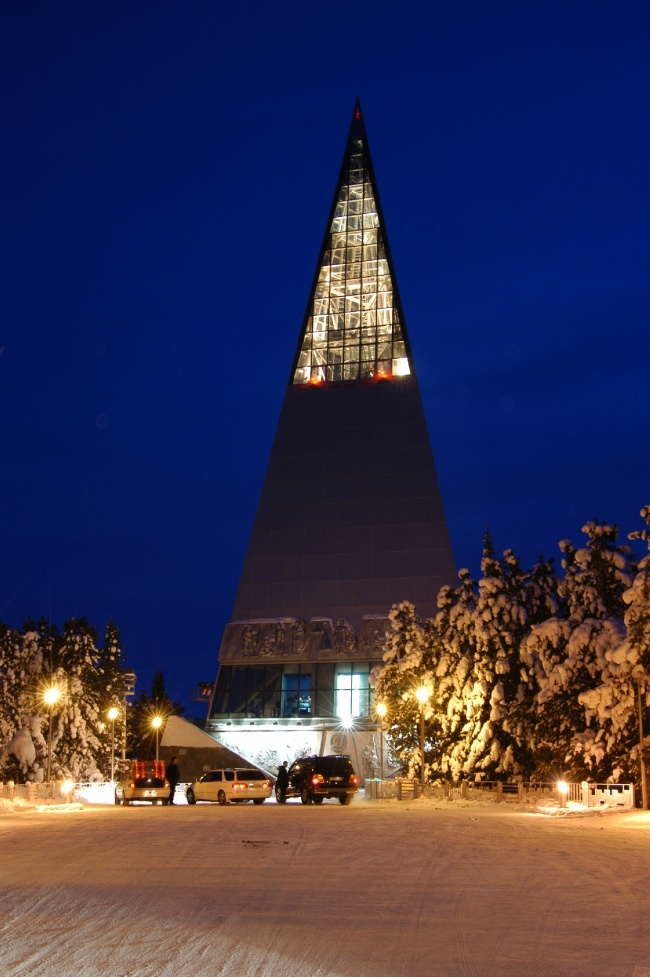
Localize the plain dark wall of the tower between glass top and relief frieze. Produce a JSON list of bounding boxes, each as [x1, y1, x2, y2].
[[232, 376, 456, 631]]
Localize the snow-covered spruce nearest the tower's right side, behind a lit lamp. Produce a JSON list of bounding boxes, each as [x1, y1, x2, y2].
[[368, 601, 440, 777]]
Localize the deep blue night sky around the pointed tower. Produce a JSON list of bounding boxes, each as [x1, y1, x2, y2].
[[0, 0, 650, 715]]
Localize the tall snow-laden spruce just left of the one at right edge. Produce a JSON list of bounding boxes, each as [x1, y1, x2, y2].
[[521, 522, 634, 780]]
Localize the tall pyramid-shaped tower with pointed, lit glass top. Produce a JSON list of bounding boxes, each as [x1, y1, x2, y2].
[[209, 102, 456, 744]]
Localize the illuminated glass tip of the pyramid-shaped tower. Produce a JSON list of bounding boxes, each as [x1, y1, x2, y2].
[[293, 125, 411, 384]]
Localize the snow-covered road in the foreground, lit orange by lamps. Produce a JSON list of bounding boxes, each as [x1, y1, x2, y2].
[[0, 799, 650, 977]]
